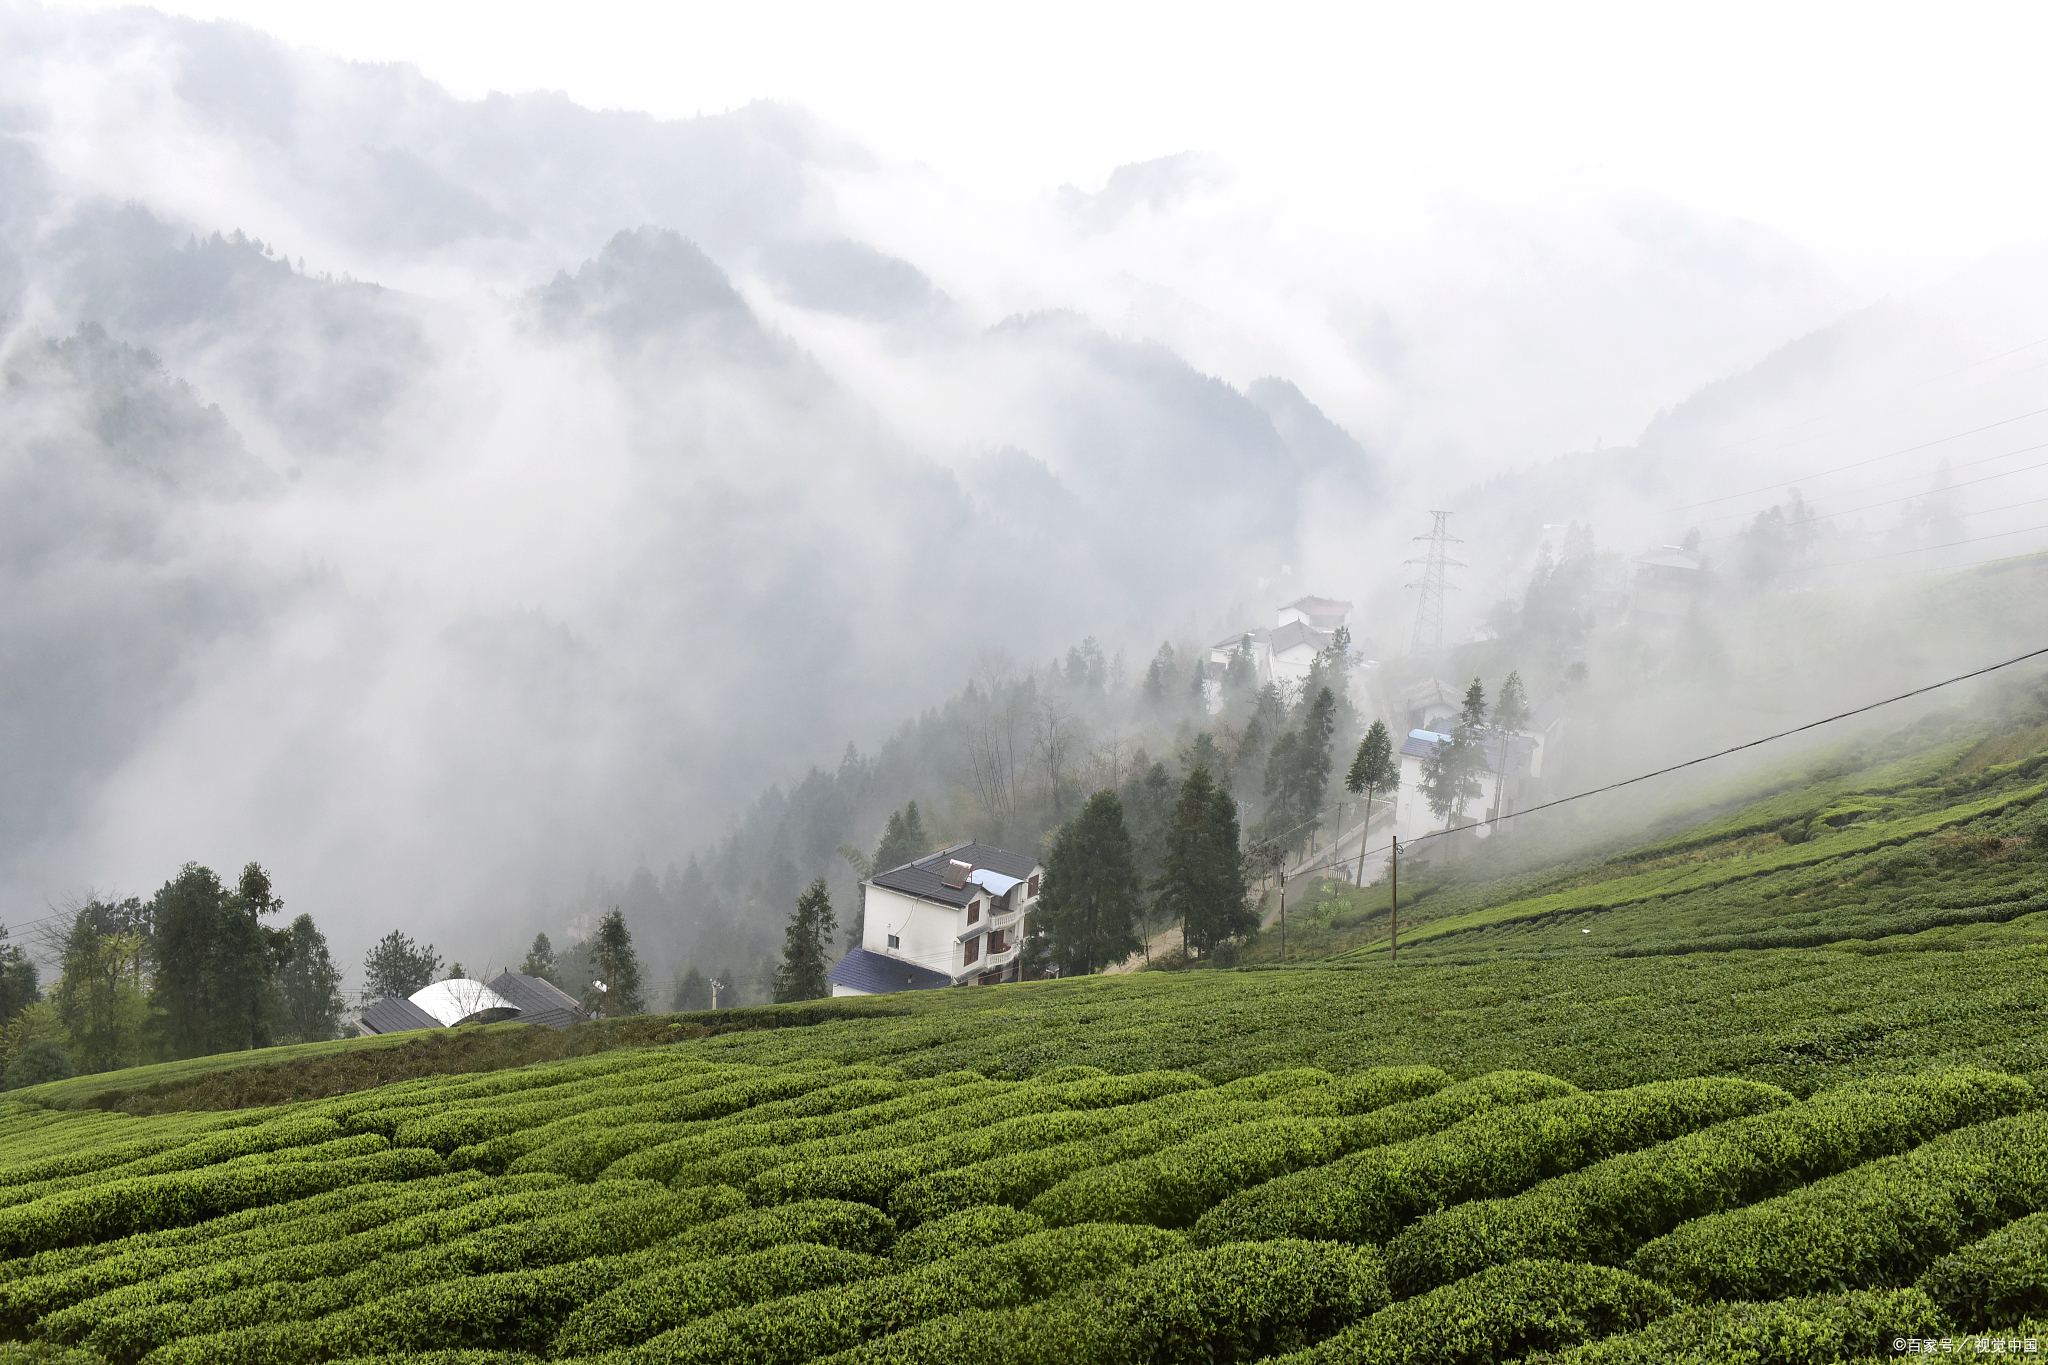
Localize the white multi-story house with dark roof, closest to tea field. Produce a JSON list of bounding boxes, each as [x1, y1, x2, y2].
[[831, 843, 1044, 995]]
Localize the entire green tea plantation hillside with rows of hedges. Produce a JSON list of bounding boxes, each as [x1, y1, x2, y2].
[[0, 699, 2048, 1365]]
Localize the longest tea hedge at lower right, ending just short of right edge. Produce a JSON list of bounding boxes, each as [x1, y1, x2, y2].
[[1386, 1068, 2030, 1297]]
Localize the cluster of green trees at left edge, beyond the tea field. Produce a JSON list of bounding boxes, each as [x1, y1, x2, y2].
[[0, 864, 342, 1087]]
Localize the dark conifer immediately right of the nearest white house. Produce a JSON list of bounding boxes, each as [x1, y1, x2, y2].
[[1038, 792, 1145, 976]]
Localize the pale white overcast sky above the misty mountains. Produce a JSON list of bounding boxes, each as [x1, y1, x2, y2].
[[44, 0, 2048, 293]]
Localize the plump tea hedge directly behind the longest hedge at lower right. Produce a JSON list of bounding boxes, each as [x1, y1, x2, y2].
[[1194, 1076, 1792, 1244]]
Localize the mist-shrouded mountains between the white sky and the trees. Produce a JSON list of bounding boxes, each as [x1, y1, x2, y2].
[[0, 6, 2048, 994]]
